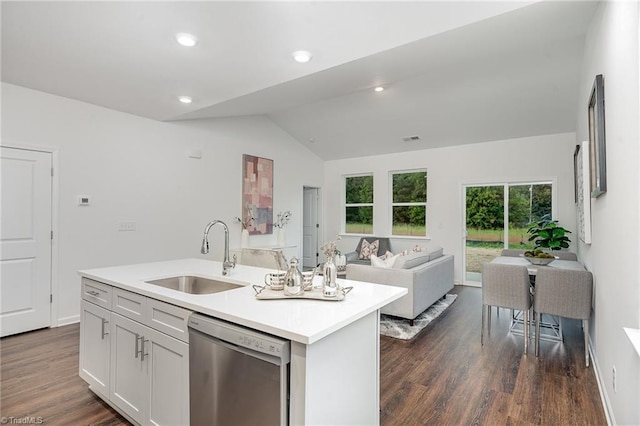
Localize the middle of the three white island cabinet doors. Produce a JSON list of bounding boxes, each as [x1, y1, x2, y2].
[[109, 312, 148, 423]]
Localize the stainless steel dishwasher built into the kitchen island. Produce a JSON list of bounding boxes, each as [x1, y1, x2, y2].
[[189, 314, 291, 426]]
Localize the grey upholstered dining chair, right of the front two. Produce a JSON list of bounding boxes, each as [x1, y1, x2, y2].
[[533, 268, 593, 367]]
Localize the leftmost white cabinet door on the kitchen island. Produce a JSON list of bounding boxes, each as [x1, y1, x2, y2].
[[80, 300, 111, 397]]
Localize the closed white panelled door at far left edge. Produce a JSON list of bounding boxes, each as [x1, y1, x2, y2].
[[0, 147, 52, 336]]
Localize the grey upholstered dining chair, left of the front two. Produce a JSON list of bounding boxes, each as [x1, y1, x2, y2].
[[480, 263, 532, 354]]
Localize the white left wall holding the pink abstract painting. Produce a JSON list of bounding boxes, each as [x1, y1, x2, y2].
[[2, 83, 323, 325]]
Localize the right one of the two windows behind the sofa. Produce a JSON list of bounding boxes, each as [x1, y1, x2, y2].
[[391, 170, 427, 237]]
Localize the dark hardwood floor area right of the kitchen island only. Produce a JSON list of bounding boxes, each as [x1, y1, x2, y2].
[[380, 286, 606, 425]]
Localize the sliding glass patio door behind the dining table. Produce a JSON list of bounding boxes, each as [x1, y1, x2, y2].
[[463, 182, 553, 285]]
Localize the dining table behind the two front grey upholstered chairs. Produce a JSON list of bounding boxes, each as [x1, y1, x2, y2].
[[491, 256, 586, 342]]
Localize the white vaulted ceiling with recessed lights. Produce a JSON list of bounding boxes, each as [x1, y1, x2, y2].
[[1, 1, 598, 160]]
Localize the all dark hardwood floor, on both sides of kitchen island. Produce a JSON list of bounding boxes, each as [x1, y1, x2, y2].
[[0, 287, 606, 425]]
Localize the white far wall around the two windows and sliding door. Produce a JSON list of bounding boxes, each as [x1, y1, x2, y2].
[[324, 133, 576, 283]]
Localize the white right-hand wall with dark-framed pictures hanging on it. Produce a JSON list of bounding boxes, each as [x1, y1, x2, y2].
[[576, 1, 640, 425]]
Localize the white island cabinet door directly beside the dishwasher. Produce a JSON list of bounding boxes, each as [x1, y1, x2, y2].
[[144, 330, 189, 425]]
